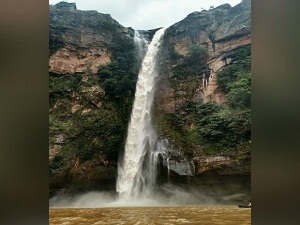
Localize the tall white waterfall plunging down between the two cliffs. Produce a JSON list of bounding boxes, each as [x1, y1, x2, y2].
[[117, 29, 165, 200]]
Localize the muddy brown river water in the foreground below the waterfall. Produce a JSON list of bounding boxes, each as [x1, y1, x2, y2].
[[49, 205, 251, 225]]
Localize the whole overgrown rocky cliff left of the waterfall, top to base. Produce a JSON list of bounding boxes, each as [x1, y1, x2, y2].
[[49, 2, 136, 195]]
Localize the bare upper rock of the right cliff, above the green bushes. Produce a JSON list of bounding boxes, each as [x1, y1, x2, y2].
[[157, 0, 251, 112]]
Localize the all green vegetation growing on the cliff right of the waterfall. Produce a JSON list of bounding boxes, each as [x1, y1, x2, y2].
[[158, 46, 251, 156]]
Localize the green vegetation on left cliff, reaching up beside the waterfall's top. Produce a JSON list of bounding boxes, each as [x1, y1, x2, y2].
[[49, 32, 139, 172]]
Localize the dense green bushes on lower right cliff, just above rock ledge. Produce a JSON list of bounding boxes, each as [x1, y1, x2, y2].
[[160, 101, 251, 156]]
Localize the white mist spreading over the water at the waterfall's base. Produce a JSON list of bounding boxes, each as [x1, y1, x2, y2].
[[49, 183, 250, 208]]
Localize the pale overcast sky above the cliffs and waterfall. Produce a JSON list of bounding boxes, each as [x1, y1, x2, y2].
[[49, 0, 241, 30]]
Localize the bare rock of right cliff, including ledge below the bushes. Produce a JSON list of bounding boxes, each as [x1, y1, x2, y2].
[[156, 0, 251, 175]]
